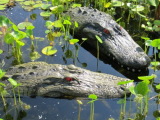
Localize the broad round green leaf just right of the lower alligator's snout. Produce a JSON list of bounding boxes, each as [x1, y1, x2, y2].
[[135, 82, 149, 96]]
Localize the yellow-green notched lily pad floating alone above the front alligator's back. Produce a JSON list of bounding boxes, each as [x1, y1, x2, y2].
[[42, 46, 57, 55]]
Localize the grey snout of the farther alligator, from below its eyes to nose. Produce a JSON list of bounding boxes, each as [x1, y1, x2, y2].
[[100, 35, 150, 72]]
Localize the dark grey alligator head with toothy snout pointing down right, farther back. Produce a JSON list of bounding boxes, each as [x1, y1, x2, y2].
[[63, 7, 150, 72]]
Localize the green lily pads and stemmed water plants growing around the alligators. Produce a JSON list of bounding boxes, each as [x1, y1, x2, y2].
[[0, 0, 160, 120]]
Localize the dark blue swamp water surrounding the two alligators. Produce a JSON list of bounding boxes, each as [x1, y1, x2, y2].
[[0, 0, 160, 120]]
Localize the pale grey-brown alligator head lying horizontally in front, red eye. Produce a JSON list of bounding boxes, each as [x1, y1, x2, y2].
[[1, 62, 134, 98]]
